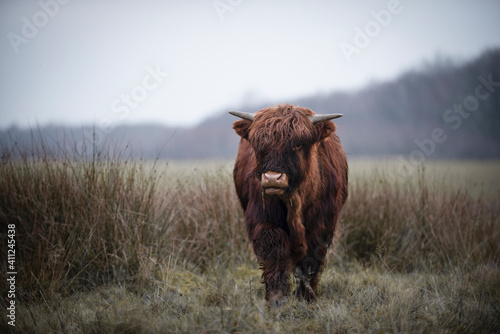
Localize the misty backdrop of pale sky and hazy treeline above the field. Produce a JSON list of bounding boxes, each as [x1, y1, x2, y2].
[[0, 0, 500, 161]]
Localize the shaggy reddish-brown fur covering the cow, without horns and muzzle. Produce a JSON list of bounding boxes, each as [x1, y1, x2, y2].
[[233, 105, 348, 307]]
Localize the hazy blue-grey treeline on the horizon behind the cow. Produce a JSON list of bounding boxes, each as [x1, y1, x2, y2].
[[0, 49, 500, 161]]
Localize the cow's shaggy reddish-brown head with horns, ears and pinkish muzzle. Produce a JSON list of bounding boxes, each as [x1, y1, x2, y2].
[[229, 105, 342, 195]]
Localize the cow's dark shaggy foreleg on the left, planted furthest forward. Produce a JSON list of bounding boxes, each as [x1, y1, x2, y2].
[[251, 224, 292, 308]]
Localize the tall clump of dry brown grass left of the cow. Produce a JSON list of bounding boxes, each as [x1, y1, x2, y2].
[[0, 136, 177, 300]]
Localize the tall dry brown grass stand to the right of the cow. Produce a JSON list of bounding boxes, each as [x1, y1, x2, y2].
[[341, 167, 500, 272]]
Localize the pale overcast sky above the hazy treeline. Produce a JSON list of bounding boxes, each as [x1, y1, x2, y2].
[[0, 0, 500, 128]]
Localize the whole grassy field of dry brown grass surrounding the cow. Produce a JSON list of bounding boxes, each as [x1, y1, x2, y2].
[[0, 143, 500, 333]]
